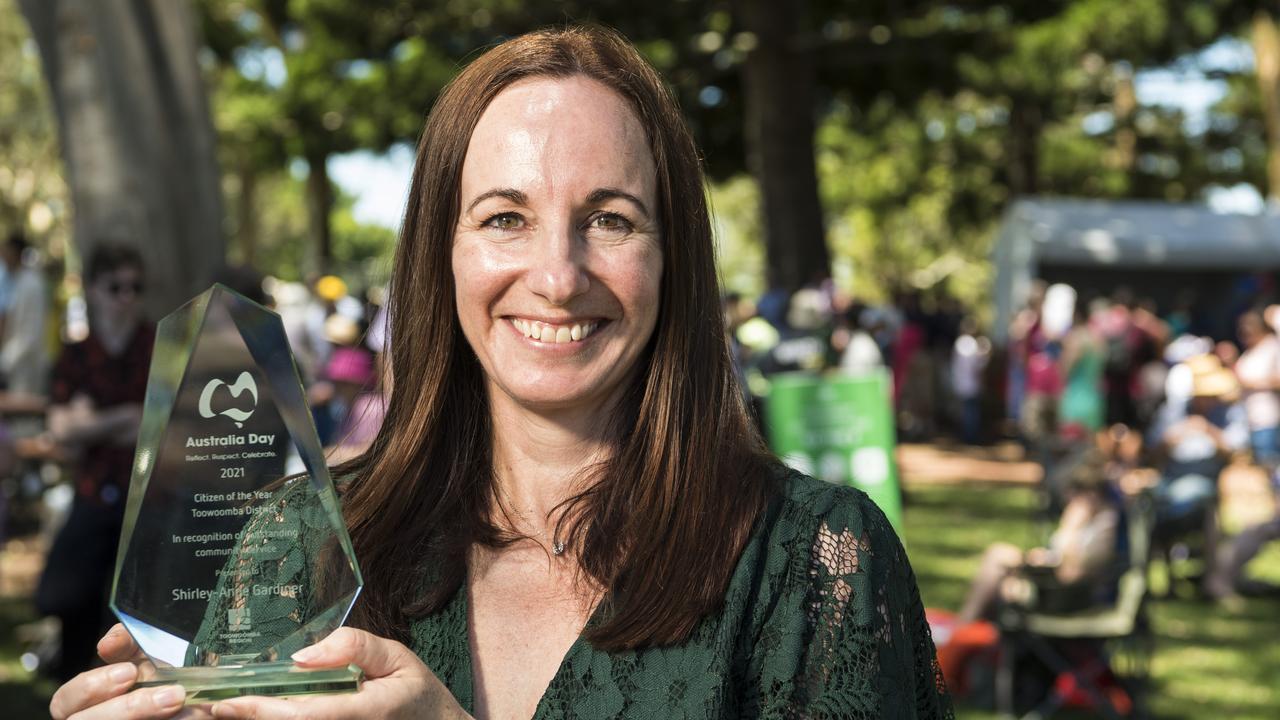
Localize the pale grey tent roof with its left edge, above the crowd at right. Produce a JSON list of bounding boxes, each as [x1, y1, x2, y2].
[[993, 199, 1280, 341]]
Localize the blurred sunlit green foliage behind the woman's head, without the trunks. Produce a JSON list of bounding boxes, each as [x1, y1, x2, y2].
[[186, 0, 1266, 297]]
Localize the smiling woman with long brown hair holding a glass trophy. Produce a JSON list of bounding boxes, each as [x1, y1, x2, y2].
[[54, 29, 950, 719]]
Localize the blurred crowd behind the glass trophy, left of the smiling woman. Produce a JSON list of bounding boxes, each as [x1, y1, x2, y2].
[[0, 229, 389, 679]]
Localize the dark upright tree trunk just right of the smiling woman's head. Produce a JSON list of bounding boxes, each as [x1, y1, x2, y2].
[[739, 0, 831, 290]]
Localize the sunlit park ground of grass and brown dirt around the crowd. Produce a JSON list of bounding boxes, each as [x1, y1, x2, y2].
[[0, 446, 1280, 720]]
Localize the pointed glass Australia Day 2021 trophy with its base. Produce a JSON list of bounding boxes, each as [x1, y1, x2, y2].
[[111, 284, 364, 703]]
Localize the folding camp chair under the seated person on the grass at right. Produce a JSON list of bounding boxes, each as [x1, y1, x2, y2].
[[996, 495, 1155, 720]]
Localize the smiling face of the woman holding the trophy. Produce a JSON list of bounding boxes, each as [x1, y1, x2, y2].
[[453, 77, 662, 410]]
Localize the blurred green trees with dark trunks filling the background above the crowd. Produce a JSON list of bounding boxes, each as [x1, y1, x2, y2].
[[0, 0, 1280, 308]]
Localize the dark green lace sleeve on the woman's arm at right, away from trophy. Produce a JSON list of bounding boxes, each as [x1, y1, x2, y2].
[[753, 488, 954, 720]]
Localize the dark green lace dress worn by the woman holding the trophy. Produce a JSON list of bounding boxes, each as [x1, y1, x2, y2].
[[412, 475, 954, 720]]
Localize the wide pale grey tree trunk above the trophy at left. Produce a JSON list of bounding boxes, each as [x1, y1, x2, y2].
[[19, 0, 225, 316]]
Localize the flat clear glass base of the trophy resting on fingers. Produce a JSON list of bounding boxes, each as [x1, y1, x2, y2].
[[137, 662, 365, 705]]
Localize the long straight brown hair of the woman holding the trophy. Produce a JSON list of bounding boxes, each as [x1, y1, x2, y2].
[[340, 27, 772, 650]]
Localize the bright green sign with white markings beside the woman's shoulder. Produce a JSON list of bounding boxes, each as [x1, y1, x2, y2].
[[765, 370, 902, 534]]
